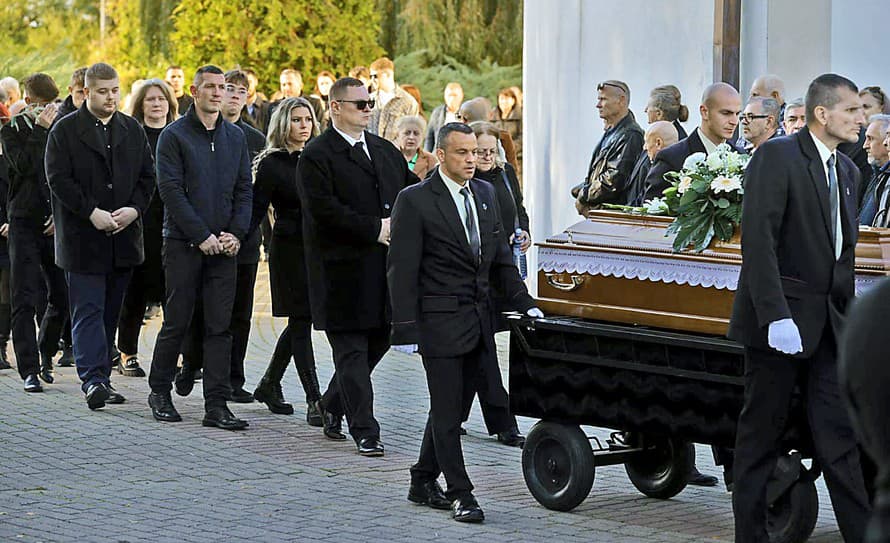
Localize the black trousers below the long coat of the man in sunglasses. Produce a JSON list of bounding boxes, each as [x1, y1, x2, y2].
[[321, 326, 389, 442]]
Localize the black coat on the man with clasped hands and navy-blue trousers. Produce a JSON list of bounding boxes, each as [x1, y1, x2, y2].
[[46, 102, 155, 273]]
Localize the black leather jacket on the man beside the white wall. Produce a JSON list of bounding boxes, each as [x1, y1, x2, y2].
[[572, 112, 643, 215]]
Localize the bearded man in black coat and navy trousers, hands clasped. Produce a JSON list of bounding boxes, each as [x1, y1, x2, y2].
[[45, 62, 155, 409]]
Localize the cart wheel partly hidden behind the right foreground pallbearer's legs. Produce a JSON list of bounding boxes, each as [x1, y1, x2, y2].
[[766, 479, 819, 543]]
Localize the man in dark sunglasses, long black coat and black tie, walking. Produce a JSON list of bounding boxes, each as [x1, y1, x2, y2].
[[297, 77, 417, 456]]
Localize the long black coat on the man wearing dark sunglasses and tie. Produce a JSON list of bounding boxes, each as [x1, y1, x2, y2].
[[297, 128, 417, 331]]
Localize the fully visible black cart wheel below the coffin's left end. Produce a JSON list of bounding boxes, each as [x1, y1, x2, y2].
[[522, 421, 594, 511]]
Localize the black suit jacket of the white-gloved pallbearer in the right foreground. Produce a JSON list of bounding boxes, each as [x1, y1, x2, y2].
[[728, 128, 859, 358]]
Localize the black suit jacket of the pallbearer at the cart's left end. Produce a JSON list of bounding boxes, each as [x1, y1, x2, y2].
[[387, 170, 534, 360]]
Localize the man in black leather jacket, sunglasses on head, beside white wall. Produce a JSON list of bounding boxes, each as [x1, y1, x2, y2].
[[572, 79, 643, 216]]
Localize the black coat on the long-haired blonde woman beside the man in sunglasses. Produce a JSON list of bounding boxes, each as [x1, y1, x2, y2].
[[250, 151, 311, 319]]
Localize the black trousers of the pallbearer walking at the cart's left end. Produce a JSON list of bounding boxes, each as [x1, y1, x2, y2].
[[411, 340, 497, 500]]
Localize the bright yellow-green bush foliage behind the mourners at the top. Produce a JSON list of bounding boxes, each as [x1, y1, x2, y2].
[[171, 0, 383, 93]]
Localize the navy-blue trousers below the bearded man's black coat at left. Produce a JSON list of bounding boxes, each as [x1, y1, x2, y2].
[[67, 269, 133, 392]]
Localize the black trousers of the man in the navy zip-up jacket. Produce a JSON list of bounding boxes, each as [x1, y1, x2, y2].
[[148, 239, 237, 409]]
